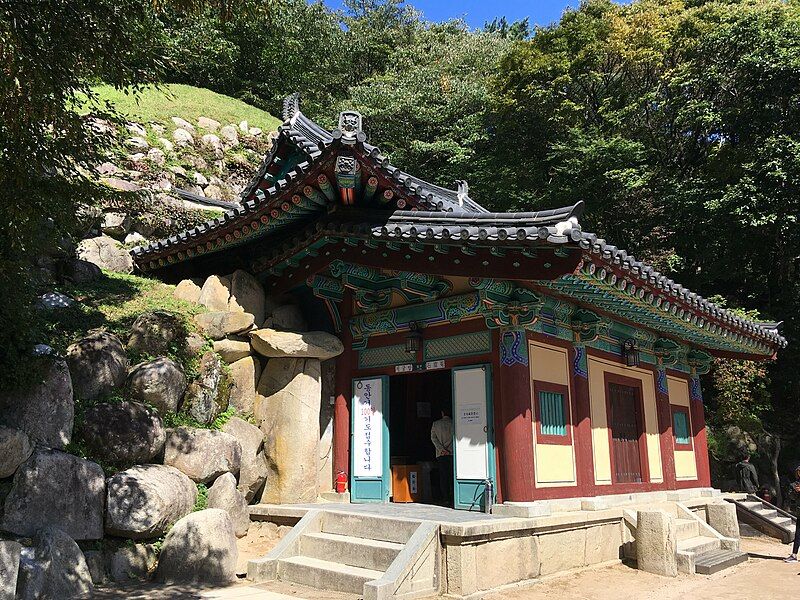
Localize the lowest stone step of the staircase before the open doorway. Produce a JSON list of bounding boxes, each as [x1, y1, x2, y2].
[[278, 556, 383, 594]]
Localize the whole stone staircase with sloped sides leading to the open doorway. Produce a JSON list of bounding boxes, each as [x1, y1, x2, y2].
[[248, 511, 439, 599]]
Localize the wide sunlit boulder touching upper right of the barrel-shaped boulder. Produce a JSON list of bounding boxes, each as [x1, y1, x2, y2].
[[164, 427, 242, 483]]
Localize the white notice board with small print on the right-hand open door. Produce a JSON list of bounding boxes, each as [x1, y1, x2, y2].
[[453, 367, 489, 480]]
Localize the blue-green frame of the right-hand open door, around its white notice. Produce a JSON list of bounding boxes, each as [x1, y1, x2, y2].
[[451, 364, 497, 511]]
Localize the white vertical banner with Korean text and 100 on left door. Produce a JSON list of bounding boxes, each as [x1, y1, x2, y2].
[[353, 377, 383, 477]]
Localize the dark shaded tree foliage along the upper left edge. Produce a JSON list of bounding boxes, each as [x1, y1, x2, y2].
[[0, 0, 166, 385]]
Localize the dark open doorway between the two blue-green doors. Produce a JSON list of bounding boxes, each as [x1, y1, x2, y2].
[[389, 370, 453, 507]]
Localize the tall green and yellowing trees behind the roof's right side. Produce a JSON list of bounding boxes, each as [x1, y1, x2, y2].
[[489, 0, 800, 468]]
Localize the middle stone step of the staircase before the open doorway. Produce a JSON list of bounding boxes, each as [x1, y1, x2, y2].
[[300, 533, 403, 571]]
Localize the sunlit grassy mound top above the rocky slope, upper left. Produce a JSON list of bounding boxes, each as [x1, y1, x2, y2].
[[86, 83, 281, 132]]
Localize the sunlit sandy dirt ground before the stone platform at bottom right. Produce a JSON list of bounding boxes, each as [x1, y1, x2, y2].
[[486, 537, 800, 600]]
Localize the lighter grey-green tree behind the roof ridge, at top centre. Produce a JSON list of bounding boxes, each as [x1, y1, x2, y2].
[[342, 21, 510, 197]]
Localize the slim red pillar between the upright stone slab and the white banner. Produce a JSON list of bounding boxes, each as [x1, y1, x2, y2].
[[333, 290, 355, 480]]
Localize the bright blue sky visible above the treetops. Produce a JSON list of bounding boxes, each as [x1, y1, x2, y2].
[[325, 0, 579, 27]]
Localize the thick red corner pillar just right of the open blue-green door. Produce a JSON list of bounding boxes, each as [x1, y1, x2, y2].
[[494, 329, 535, 502]]
